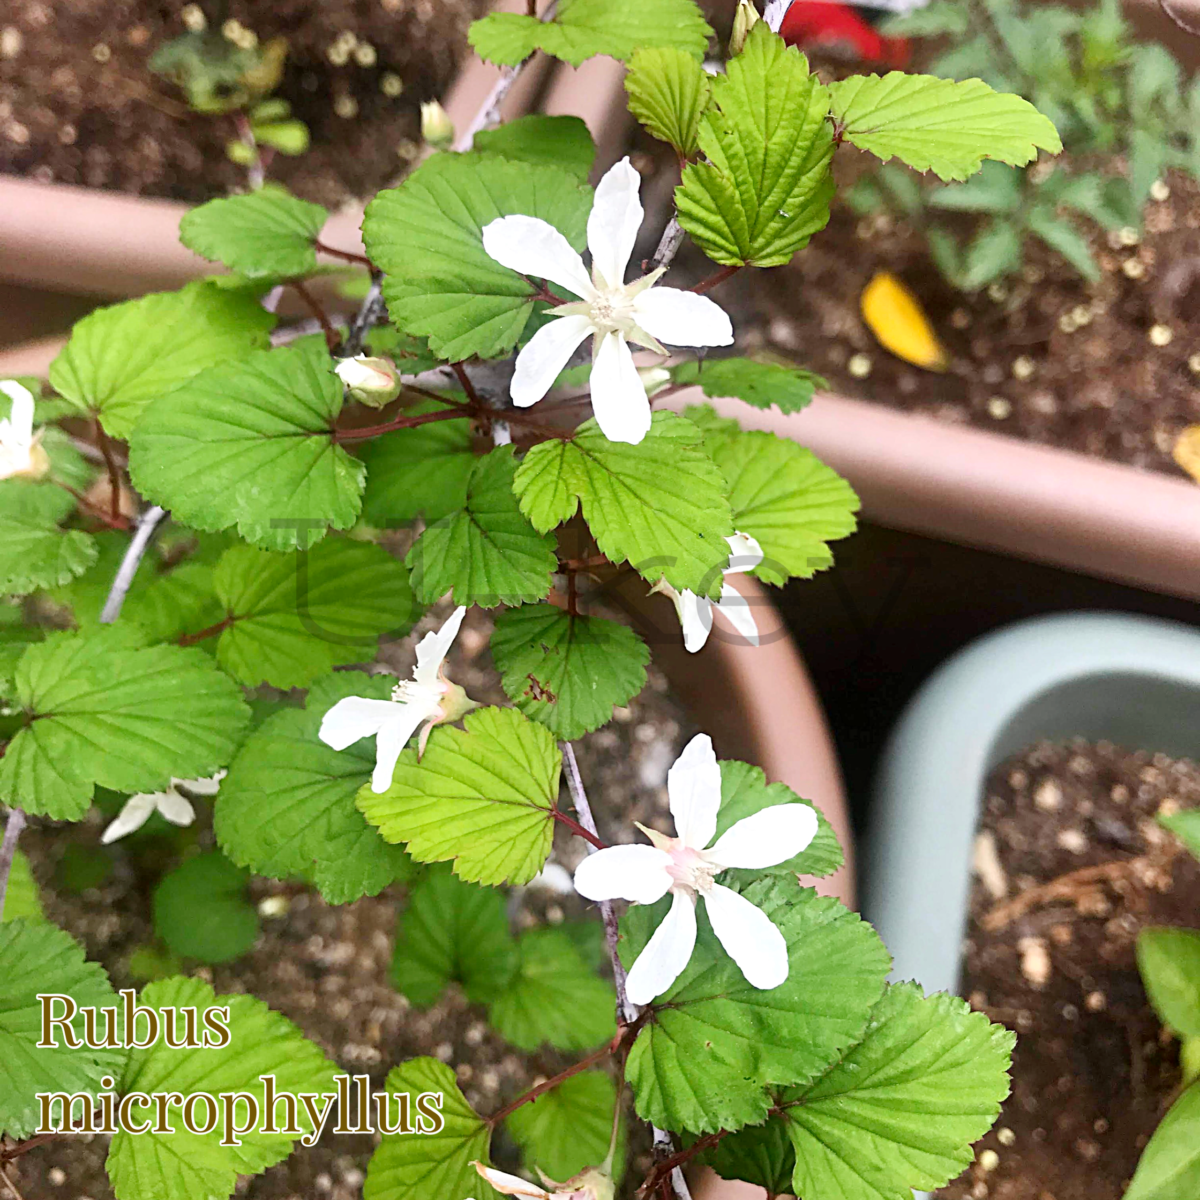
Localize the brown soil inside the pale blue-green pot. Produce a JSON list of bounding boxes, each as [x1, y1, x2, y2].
[[938, 742, 1200, 1200]]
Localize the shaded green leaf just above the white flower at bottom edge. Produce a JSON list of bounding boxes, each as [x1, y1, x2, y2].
[[504, 1070, 625, 1180]]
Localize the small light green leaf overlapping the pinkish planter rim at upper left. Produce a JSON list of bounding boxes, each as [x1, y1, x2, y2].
[[179, 185, 329, 278]]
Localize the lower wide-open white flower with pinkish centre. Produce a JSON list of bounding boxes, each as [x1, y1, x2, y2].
[[575, 733, 817, 1004]]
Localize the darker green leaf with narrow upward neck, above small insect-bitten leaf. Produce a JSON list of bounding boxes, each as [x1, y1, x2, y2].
[[406, 446, 558, 608]]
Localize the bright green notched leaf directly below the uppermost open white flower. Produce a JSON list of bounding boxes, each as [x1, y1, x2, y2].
[[514, 413, 733, 595]]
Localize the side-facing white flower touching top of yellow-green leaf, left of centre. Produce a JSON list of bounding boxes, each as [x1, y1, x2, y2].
[[319, 605, 479, 792]]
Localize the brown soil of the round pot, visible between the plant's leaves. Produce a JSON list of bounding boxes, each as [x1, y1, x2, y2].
[[0, 608, 695, 1200]]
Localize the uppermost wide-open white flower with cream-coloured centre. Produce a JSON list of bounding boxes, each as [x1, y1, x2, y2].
[[484, 158, 733, 445]]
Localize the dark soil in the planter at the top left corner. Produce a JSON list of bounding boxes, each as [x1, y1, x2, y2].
[[0, 0, 486, 205]]
